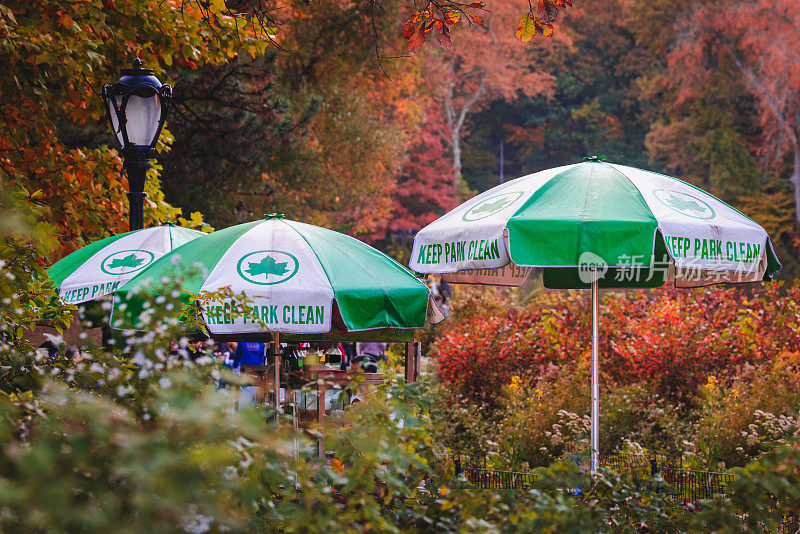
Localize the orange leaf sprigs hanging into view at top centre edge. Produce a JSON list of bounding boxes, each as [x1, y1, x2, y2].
[[403, 0, 572, 52]]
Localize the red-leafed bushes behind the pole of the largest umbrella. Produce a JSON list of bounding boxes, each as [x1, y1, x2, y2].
[[433, 284, 800, 404]]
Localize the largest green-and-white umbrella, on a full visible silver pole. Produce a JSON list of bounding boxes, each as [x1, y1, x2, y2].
[[410, 158, 780, 469]]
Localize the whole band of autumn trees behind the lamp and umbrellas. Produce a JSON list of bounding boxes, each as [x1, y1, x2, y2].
[[0, 0, 800, 275]]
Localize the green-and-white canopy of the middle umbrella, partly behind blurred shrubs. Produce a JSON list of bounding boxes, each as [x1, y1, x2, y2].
[[112, 215, 440, 338]]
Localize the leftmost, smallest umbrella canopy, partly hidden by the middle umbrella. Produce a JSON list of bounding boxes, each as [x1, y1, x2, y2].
[[47, 224, 207, 304]]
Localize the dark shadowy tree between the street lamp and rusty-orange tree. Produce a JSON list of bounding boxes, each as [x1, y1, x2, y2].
[[159, 53, 318, 227]]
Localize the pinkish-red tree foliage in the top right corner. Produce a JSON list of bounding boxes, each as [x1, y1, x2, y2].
[[669, 0, 800, 221]]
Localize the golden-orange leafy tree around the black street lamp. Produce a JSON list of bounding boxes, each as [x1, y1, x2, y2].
[[0, 0, 271, 257]]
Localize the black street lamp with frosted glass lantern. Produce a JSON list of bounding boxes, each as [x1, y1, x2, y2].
[[103, 57, 172, 230]]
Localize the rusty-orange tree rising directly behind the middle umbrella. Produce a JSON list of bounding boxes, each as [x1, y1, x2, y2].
[[253, 0, 425, 236]]
